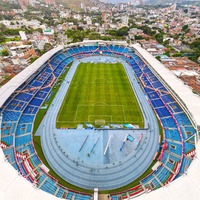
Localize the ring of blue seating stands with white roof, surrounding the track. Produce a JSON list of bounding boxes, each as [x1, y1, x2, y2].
[[0, 41, 200, 200]]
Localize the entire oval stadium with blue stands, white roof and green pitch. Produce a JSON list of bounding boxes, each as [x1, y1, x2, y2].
[[0, 41, 200, 200]]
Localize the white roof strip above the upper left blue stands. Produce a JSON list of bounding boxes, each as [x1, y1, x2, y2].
[[0, 46, 63, 107]]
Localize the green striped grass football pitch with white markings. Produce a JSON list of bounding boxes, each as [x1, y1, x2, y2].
[[56, 63, 144, 128]]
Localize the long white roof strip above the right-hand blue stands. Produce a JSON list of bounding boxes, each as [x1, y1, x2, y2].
[[132, 44, 200, 126]]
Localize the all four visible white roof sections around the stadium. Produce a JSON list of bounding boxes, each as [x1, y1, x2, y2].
[[0, 41, 200, 200]]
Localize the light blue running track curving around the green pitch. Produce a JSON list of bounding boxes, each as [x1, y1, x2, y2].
[[36, 55, 159, 190]]
